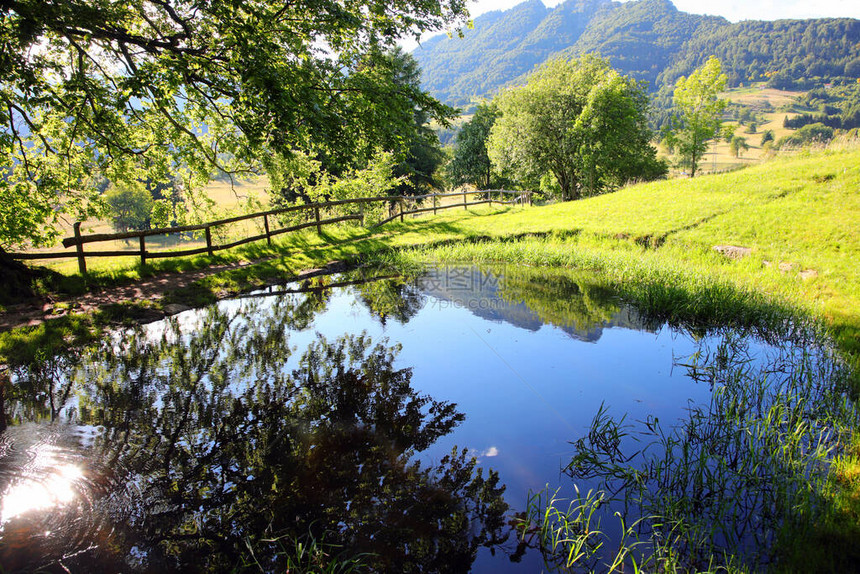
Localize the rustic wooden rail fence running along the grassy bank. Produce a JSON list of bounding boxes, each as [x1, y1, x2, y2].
[[11, 189, 532, 274]]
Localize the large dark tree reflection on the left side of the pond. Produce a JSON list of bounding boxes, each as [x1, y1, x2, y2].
[[6, 298, 506, 572]]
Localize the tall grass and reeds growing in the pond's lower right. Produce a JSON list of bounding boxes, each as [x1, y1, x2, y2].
[[520, 331, 858, 572]]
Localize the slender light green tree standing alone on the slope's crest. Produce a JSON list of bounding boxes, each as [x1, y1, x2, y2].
[[669, 56, 727, 177]]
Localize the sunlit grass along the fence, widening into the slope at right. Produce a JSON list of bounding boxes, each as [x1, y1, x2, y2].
[[16, 148, 860, 352]]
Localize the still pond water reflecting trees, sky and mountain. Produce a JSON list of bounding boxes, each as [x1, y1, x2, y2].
[[0, 266, 849, 572]]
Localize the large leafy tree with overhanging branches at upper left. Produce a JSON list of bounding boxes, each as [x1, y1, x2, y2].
[[0, 0, 465, 253]]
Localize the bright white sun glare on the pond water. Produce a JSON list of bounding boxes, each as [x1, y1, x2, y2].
[[0, 445, 84, 524]]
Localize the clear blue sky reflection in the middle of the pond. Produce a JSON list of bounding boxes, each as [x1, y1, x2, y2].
[[245, 291, 708, 504]]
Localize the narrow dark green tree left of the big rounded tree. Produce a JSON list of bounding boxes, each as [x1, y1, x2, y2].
[[448, 102, 499, 189]]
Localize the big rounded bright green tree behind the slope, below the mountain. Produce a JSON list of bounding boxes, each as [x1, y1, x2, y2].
[[487, 55, 664, 200]]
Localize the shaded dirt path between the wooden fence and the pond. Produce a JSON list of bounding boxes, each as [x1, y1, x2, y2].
[[0, 261, 251, 331]]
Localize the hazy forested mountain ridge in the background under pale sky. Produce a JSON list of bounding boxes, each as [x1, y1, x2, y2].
[[413, 0, 860, 106]]
